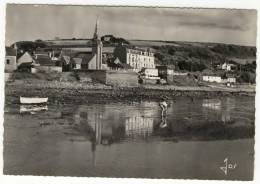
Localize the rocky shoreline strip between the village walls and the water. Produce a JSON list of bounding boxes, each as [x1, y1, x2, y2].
[[5, 80, 255, 104]]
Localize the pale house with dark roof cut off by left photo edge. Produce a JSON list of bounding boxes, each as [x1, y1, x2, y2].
[[5, 47, 17, 72]]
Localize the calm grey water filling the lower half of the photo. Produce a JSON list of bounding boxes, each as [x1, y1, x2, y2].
[[4, 97, 255, 180]]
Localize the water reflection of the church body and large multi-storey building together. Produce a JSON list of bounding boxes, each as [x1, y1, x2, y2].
[[74, 103, 157, 145]]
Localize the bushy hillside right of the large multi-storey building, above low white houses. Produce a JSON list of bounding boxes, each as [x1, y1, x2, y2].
[[129, 40, 256, 84]]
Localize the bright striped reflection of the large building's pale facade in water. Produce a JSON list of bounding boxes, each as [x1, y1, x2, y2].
[[125, 116, 153, 137]]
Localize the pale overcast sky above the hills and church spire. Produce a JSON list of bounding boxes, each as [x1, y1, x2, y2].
[[6, 5, 257, 46]]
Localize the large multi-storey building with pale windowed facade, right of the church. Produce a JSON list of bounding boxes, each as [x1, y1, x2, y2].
[[114, 44, 155, 71]]
